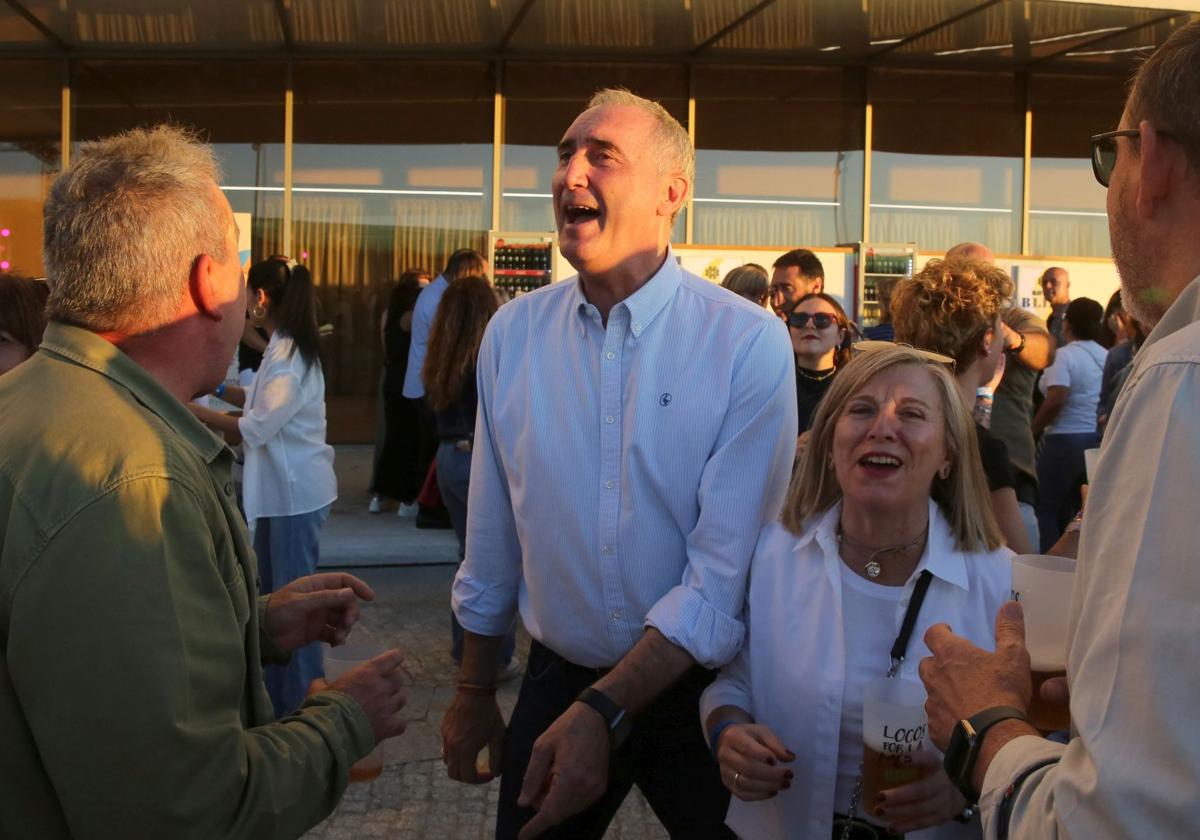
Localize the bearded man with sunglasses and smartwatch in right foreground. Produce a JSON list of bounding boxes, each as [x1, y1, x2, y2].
[[920, 23, 1200, 840]]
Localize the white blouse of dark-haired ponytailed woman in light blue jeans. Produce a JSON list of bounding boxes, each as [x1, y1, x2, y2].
[[238, 330, 337, 523]]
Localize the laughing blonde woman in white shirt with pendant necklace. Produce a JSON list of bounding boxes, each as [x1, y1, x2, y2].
[[701, 346, 1012, 840]]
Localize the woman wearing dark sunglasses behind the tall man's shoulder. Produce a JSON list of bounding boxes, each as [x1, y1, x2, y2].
[[787, 292, 850, 434]]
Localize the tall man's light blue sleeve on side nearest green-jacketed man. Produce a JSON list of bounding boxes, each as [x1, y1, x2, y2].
[[451, 320, 521, 636]]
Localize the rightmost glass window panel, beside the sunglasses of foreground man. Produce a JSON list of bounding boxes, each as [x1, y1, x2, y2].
[[1030, 74, 1126, 257]]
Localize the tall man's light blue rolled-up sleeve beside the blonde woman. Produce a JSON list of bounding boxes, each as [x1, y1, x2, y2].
[[646, 320, 797, 668]]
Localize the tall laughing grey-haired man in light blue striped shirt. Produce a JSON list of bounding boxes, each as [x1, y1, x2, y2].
[[442, 91, 796, 839]]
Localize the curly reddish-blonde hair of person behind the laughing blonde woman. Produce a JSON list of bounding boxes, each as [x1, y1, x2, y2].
[[892, 259, 1013, 371]]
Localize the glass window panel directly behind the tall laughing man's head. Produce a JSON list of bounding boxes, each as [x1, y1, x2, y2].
[[500, 62, 688, 242]]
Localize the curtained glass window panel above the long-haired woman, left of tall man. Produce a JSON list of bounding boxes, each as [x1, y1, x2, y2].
[[292, 61, 496, 442]]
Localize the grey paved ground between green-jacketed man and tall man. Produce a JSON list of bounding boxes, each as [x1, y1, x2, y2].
[[305, 446, 667, 840]]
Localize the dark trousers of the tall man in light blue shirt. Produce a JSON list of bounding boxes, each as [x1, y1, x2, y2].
[[496, 642, 734, 840]]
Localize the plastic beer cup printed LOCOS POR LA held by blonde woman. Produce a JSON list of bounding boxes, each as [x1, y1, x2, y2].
[[862, 679, 937, 812]]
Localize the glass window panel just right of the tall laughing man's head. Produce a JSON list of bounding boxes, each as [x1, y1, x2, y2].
[[692, 66, 863, 248]]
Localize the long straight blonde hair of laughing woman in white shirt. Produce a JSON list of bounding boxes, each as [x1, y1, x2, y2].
[[780, 346, 1004, 551]]
